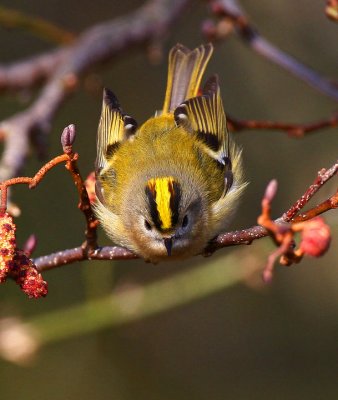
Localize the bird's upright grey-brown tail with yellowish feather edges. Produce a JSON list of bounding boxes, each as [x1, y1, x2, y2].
[[162, 43, 213, 114]]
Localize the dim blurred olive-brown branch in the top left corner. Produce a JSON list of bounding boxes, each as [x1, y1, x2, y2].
[[0, 6, 75, 44]]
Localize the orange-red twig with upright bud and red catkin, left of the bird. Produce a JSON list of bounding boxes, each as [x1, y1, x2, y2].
[[0, 125, 97, 298]]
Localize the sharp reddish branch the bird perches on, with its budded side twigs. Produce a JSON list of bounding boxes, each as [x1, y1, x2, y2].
[[0, 125, 338, 274]]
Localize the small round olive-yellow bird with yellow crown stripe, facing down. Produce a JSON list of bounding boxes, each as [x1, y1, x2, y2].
[[95, 44, 245, 263]]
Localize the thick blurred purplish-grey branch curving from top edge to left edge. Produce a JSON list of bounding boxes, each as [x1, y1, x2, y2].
[[0, 0, 189, 180]]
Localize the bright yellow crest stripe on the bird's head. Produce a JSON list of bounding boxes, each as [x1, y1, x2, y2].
[[148, 176, 174, 230]]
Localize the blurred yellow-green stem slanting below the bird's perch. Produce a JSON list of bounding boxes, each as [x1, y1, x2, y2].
[[0, 251, 260, 362]]
